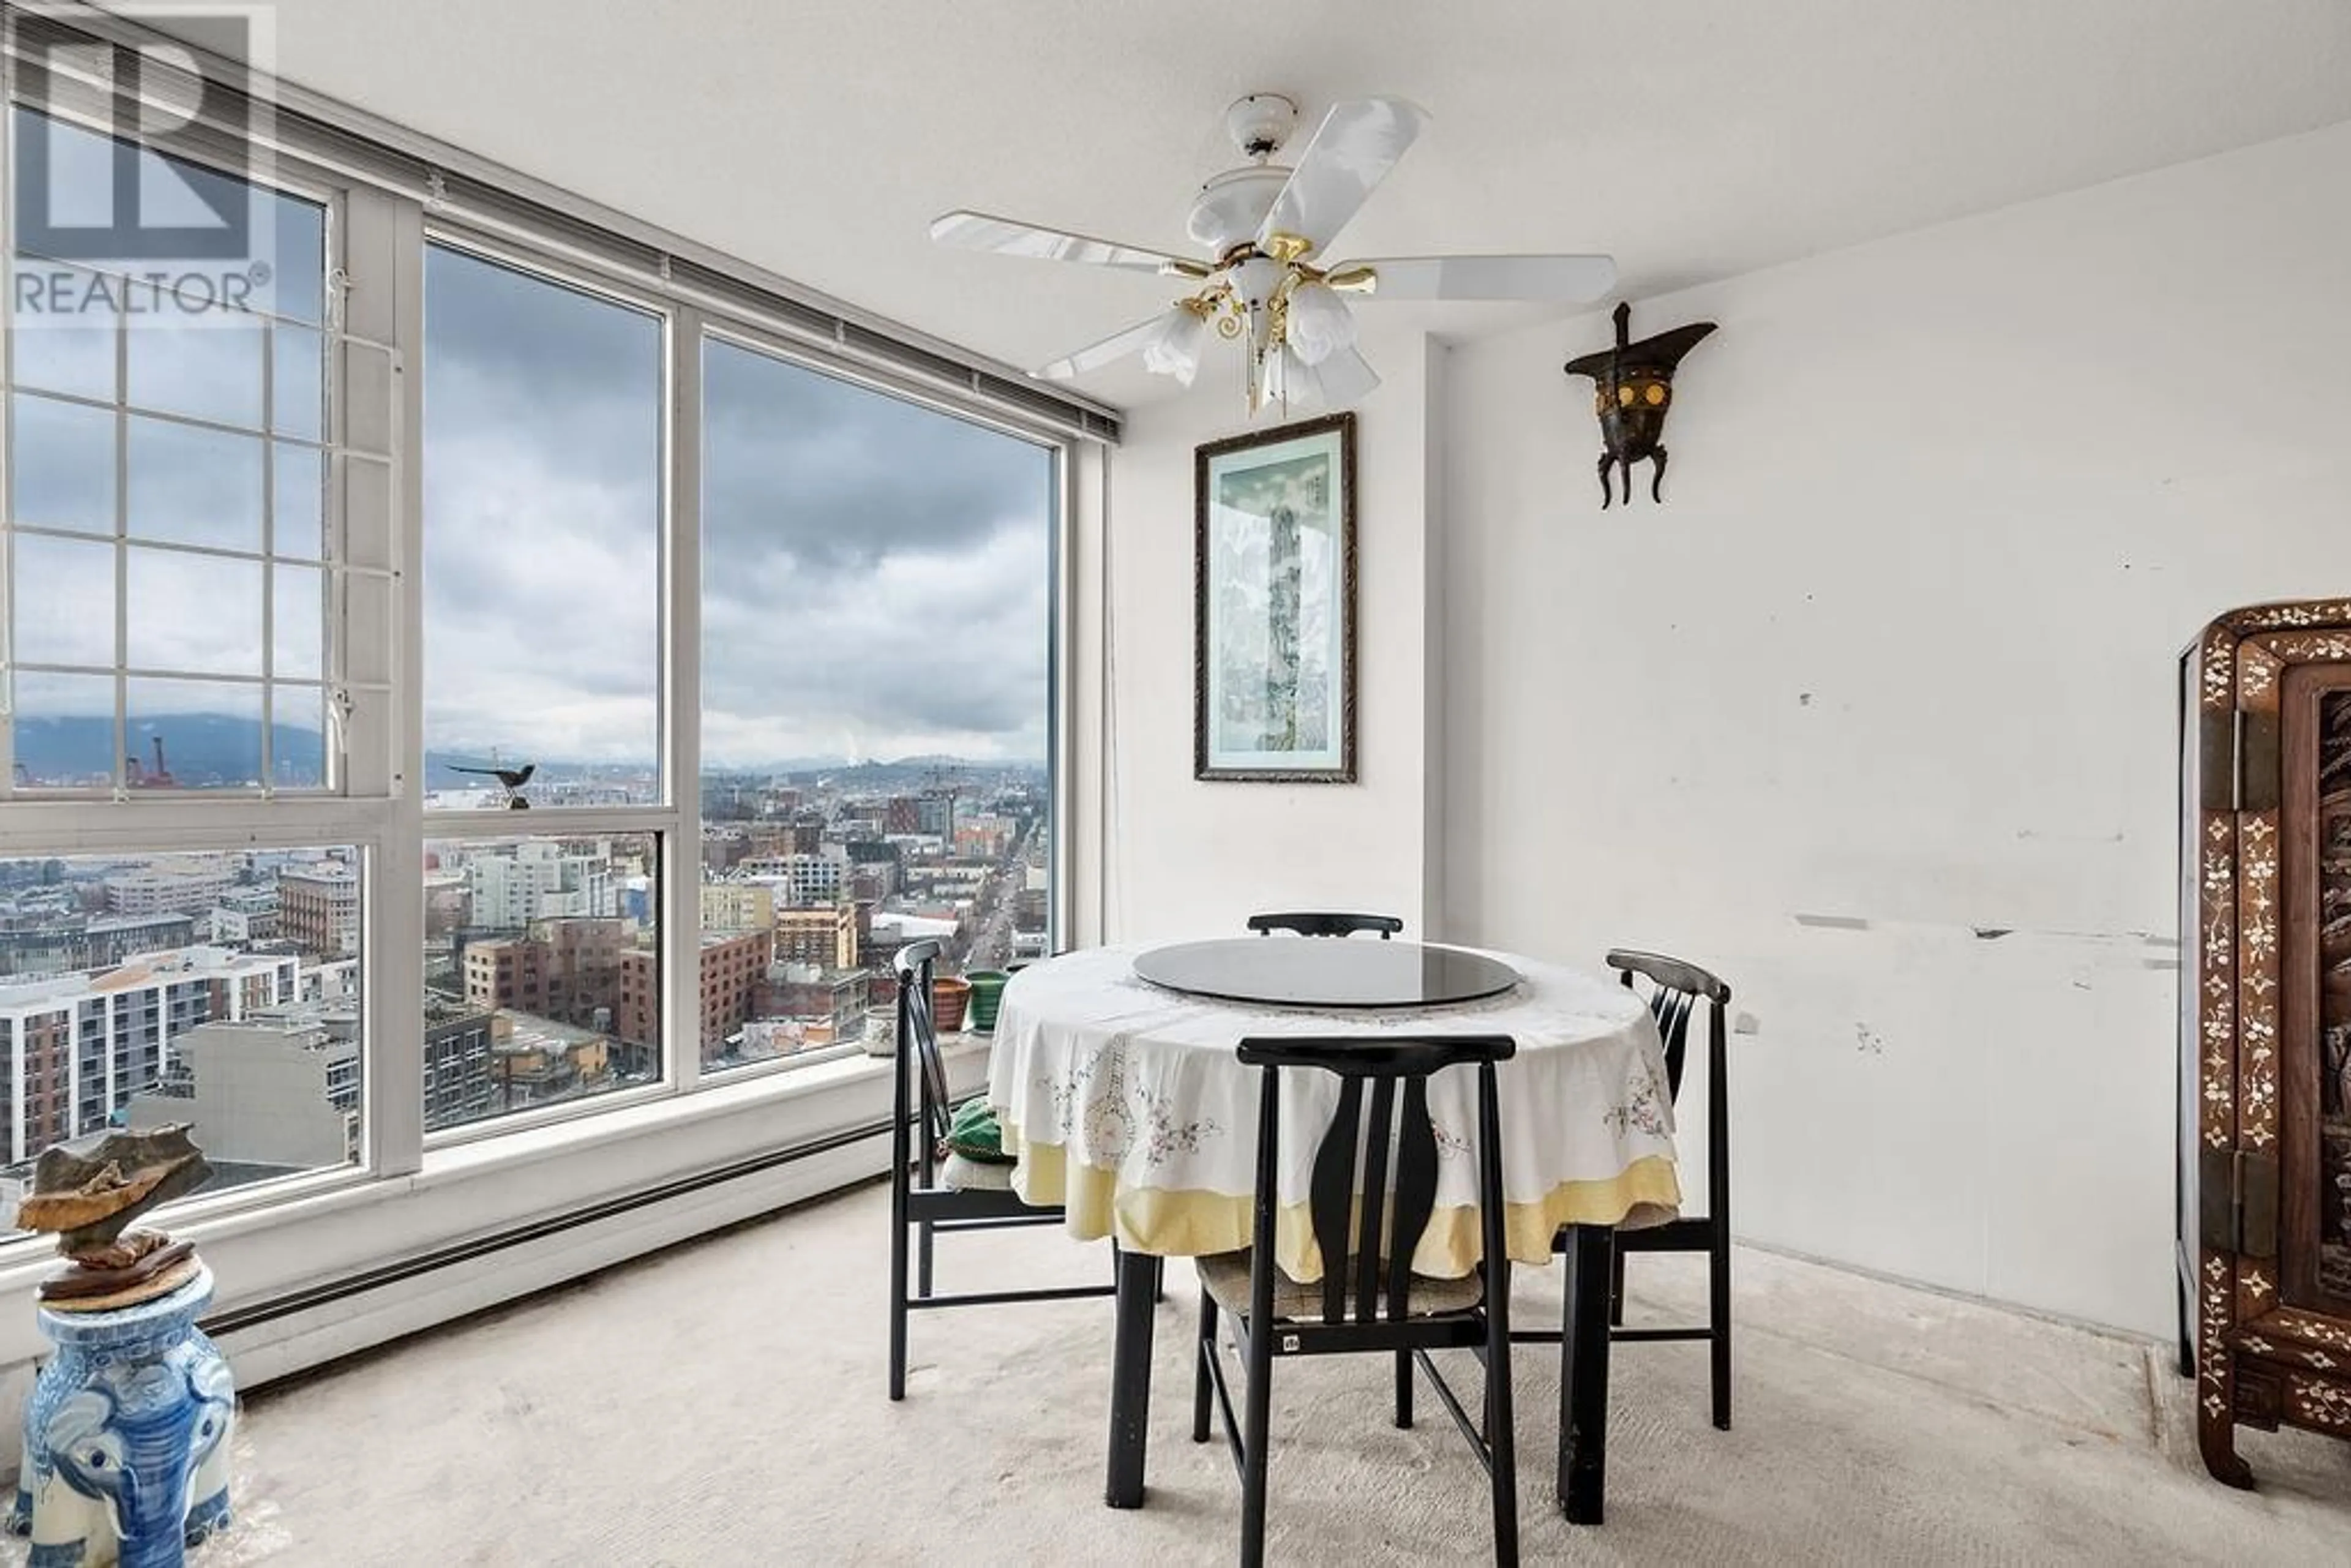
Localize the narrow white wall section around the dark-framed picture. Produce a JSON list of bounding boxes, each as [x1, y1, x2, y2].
[[1079, 331, 1444, 940]]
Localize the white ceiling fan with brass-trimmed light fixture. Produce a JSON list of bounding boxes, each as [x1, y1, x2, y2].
[[931, 92, 1615, 414]]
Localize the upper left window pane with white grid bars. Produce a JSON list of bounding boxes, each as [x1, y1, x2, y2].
[[0, 110, 329, 795]]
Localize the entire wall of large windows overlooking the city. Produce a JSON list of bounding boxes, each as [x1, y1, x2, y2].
[[0, 21, 1067, 1250]]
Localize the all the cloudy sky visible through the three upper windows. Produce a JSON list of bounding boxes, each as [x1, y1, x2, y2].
[[7, 102, 1053, 769]]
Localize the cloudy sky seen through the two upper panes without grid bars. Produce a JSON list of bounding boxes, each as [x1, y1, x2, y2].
[[426, 249, 1053, 767]]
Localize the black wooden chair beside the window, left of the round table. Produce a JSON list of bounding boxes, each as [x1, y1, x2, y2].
[[889, 940, 1117, 1399]]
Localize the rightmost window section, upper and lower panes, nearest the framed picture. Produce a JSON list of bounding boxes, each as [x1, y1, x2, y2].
[[700, 339, 1056, 1067]]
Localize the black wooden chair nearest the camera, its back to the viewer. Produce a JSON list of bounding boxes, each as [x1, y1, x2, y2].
[[1192, 1034, 1519, 1568]]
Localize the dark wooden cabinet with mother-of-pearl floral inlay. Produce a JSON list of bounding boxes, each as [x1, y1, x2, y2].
[[2180, 599, 2351, 1486]]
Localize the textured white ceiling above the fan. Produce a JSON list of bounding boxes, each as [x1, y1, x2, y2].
[[137, 0, 2351, 411]]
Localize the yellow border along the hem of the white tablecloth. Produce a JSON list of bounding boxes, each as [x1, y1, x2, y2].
[[1004, 1126, 1681, 1283]]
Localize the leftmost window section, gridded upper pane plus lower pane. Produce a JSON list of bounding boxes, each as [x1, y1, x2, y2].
[[0, 108, 390, 1199]]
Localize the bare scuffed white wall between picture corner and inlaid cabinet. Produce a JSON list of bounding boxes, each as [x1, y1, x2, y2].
[[1439, 127, 2351, 1333]]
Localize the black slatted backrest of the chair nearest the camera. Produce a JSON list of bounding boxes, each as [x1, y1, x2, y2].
[[1239, 1034, 1517, 1324]]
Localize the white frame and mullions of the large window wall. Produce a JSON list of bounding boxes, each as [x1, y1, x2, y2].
[[0, 14, 1081, 1272]]
